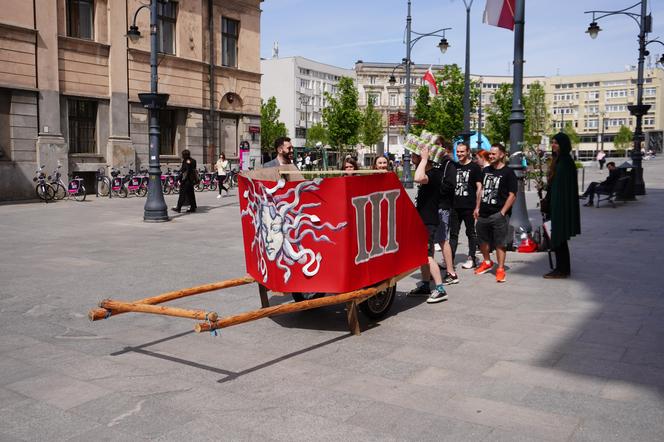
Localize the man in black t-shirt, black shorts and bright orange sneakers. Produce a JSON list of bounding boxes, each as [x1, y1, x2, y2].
[[473, 143, 518, 282]]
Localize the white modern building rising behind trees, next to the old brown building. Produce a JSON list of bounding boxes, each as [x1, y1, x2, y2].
[[261, 57, 355, 147]]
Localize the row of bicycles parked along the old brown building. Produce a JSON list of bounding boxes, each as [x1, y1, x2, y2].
[[33, 165, 238, 203]]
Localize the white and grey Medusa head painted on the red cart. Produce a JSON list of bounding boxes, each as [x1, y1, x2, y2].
[[241, 178, 347, 282]]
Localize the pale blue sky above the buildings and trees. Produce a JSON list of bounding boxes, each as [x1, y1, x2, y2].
[[261, 0, 664, 76]]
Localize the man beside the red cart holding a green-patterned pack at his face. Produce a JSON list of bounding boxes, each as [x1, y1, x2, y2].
[[408, 147, 447, 304]]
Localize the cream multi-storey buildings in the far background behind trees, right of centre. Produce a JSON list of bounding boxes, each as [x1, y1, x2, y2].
[[355, 61, 664, 157]]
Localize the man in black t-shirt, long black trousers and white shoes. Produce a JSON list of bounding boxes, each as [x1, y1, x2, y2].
[[450, 143, 482, 269]]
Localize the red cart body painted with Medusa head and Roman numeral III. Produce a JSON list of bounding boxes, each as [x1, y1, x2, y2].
[[239, 173, 427, 293]]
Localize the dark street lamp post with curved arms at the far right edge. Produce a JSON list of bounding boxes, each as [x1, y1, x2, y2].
[[585, 0, 664, 195]]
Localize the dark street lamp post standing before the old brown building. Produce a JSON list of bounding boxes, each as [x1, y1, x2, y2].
[[127, 0, 170, 223]]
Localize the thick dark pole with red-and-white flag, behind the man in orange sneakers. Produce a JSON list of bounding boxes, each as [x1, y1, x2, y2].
[[509, 0, 533, 249]]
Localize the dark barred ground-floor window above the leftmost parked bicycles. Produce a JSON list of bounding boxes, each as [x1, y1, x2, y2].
[[67, 99, 97, 153]]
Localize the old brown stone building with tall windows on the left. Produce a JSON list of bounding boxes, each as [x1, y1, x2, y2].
[[0, 0, 261, 200]]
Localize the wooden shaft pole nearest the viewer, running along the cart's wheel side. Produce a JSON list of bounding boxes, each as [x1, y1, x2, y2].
[[194, 283, 378, 333]]
